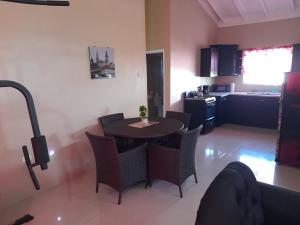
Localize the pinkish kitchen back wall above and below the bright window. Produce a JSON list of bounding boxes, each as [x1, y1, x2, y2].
[[215, 18, 300, 91]]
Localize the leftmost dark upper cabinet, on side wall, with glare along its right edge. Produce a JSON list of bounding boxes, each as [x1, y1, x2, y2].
[[200, 48, 218, 77]]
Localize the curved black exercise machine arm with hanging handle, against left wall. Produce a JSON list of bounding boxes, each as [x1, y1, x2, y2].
[[0, 80, 50, 190]]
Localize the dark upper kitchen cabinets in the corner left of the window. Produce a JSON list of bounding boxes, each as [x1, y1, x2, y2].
[[200, 45, 242, 77]]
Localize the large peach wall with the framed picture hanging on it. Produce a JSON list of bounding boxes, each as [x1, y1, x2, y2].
[[0, 0, 147, 211]]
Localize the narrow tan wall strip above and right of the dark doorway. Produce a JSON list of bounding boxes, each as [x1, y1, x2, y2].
[[145, 0, 171, 110]]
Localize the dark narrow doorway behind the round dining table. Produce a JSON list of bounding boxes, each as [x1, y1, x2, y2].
[[146, 51, 164, 119]]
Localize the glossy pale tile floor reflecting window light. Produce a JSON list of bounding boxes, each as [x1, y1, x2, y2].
[[0, 125, 300, 225]]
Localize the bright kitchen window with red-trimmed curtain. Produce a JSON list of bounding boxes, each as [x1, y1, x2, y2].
[[243, 46, 293, 85]]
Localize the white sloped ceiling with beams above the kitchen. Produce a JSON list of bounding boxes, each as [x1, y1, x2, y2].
[[198, 0, 300, 27]]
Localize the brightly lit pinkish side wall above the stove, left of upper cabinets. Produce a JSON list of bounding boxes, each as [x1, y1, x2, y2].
[[170, 0, 218, 111]]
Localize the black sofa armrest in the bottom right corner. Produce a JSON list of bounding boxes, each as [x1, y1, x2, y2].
[[258, 182, 300, 225]]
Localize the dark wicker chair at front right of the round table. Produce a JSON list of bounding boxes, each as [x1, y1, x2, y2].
[[148, 127, 201, 198]]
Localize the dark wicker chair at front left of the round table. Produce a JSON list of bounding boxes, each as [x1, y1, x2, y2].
[[86, 132, 147, 204]]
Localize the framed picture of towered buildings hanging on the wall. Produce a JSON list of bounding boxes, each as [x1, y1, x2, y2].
[[89, 46, 116, 79]]
